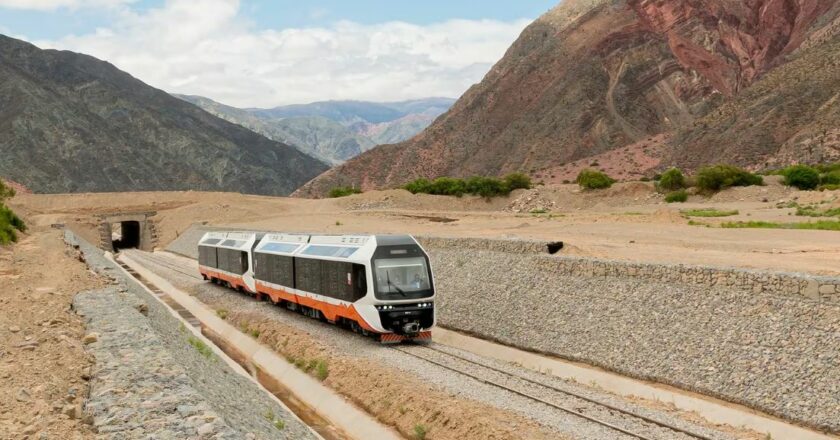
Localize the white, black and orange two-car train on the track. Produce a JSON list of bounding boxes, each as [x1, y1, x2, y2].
[[198, 231, 435, 344]]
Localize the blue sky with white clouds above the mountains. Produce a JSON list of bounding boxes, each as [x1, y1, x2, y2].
[[0, 0, 558, 107]]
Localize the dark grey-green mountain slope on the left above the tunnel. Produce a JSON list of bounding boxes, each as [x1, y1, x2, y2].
[[0, 36, 327, 195]]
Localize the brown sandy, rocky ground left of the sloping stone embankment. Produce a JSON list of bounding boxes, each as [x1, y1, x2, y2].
[[0, 226, 102, 439]]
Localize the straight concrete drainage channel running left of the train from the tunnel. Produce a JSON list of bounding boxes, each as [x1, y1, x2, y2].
[[118, 251, 401, 440]]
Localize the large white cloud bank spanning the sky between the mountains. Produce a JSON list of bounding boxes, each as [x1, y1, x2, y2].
[[36, 0, 528, 107]]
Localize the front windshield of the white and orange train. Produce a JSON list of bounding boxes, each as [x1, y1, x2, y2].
[[374, 257, 432, 299]]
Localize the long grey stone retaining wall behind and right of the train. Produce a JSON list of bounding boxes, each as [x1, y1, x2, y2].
[[168, 226, 840, 433]]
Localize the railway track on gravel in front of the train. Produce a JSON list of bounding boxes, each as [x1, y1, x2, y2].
[[392, 345, 716, 440]]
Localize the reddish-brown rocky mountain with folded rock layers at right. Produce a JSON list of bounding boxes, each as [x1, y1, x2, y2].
[[297, 0, 840, 196]]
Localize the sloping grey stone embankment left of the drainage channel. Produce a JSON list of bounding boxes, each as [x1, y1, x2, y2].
[[65, 231, 317, 439]]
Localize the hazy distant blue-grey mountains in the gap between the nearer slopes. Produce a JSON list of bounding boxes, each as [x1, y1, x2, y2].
[[176, 95, 455, 164]]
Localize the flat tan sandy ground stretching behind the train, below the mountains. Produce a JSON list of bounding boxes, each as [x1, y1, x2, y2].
[[10, 178, 840, 275]]
